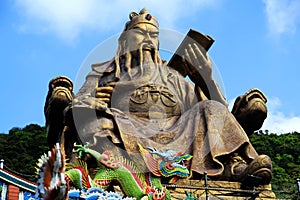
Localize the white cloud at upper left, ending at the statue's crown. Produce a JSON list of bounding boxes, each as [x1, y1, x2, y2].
[[16, 0, 126, 41]]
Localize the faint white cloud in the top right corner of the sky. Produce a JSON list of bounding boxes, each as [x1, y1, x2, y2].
[[263, 0, 300, 35]]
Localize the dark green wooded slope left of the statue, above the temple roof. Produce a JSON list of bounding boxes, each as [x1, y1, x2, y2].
[[0, 124, 48, 181]]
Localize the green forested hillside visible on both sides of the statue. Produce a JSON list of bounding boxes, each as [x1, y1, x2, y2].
[[0, 124, 300, 199]]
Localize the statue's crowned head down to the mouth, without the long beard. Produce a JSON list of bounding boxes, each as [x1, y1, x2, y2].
[[120, 8, 159, 52]]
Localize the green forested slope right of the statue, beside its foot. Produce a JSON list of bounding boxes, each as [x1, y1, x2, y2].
[[250, 131, 300, 199]]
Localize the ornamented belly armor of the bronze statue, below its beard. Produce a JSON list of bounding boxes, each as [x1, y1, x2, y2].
[[112, 83, 180, 119]]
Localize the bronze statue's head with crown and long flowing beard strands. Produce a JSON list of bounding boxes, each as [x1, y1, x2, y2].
[[115, 8, 162, 77]]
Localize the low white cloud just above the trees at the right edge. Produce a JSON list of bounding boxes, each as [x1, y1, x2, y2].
[[261, 97, 300, 134]]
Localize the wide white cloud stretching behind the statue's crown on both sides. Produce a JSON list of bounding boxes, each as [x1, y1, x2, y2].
[[15, 0, 220, 41]]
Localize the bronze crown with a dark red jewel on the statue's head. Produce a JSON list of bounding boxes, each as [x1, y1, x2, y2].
[[125, 8, 158, 30]]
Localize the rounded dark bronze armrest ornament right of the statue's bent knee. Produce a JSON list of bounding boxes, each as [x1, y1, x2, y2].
[[231, 88, 267, 135]]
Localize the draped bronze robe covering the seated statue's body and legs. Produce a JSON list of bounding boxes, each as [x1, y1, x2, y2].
[[69, 57, 258, 176]]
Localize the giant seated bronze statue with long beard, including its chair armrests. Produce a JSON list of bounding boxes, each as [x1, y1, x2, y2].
[[45, 9, 272, 195]]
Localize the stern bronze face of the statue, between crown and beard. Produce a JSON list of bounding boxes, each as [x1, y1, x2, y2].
[[126, 23, 158, 51]]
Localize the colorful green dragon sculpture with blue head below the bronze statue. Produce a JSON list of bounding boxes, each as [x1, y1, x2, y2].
[[37, 144, 192, 200]]
